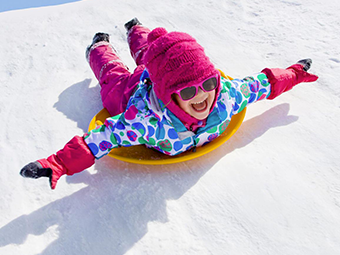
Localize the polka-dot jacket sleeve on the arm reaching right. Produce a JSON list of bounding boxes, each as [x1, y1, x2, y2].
[[221, 73, 271, 115]]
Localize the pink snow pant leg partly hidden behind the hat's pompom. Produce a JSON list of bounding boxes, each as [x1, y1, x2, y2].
[[127, 25, 150, 65]]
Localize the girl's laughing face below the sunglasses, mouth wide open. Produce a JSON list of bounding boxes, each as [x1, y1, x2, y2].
[[174, 88, 216, 120]]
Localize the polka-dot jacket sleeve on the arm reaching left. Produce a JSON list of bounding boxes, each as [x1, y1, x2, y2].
[[84, 105, 148, 159]]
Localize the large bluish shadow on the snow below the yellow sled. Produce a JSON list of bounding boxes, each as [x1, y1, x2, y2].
[[0, 102, 298, 255]]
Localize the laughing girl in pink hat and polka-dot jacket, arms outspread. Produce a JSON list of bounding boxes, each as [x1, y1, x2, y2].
[[20, 19, 318, 189]]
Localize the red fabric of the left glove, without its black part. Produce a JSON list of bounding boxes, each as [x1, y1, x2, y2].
[[38, 136, 95, 189]]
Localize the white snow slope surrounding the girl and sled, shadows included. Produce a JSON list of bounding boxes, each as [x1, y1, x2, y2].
[[0, 0, 340, 255]]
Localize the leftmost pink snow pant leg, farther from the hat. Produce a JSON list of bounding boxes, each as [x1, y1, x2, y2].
[[89, 42, 145, 116]]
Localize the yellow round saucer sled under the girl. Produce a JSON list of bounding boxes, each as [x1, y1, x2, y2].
[[88, 72, 246, 165]]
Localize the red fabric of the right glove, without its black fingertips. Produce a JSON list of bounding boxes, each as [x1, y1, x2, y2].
[[262, 64, 319, 99]]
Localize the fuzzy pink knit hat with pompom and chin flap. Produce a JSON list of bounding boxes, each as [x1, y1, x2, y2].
[[144, 27, 220, 129]]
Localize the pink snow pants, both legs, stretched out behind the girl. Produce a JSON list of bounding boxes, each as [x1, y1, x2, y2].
[[89, 25, 150, 116]]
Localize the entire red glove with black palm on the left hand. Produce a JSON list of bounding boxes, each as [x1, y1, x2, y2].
[[20, 136, 95, 189]]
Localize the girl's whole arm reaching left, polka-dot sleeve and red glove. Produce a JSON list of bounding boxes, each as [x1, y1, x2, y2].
[[20, 105, 148, 189]]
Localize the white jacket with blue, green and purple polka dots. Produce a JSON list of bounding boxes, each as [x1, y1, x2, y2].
[[84, 71, 270, 159]]
